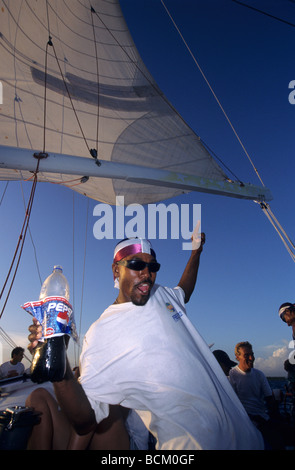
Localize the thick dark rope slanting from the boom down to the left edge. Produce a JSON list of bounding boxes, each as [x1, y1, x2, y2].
[[0, 158, 40, 318]]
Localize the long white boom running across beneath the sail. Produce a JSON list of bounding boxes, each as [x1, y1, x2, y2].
[[0, 146, 272, 202]]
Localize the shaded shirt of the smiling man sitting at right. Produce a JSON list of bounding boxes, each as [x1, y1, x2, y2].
[[229, 366, 272, 420]]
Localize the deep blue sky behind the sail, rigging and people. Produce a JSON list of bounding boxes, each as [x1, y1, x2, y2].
[[0, 0, 295, 375]]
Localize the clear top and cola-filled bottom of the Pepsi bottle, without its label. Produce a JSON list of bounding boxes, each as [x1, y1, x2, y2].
[[31, 266, 70, 383]]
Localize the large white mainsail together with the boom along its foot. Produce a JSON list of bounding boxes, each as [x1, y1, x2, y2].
[[0, 0, 271, 204]]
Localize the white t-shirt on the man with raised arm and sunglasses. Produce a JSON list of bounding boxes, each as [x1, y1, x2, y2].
[[80, 285, 263, 450]]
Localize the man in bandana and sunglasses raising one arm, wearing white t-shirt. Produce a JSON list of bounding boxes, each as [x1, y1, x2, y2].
[[28, 234, 263, 450]]
